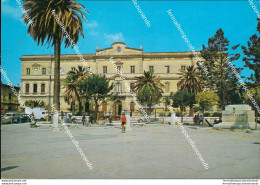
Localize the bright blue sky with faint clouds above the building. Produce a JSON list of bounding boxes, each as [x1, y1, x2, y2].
[[1, 0, 260, 85]]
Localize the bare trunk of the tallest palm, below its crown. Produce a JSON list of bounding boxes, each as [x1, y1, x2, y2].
[[53, 36, 60, 111]]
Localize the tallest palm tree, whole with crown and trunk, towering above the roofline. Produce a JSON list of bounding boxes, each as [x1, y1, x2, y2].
[[22, 0, 88, 111]]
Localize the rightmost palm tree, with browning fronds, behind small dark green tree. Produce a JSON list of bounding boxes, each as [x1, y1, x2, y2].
[[177, 66, 202, 116]]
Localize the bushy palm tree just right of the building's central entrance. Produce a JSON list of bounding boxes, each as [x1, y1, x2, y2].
[[134, 71, 164, 114]]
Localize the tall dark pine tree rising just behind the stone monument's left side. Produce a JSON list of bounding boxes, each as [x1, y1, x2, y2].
[[198, 29, 243, 110]]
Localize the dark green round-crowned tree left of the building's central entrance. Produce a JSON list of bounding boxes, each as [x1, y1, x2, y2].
[[79, 74, 113, 122]]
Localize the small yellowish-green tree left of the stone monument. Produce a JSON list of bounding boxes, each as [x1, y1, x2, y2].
[[195, 91, 219, 113]]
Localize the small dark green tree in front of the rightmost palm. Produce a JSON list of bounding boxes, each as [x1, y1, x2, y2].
[[170, 90, 194, 122]]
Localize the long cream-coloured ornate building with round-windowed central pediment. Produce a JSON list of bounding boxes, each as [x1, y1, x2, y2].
[[20, 41, 196, 115]]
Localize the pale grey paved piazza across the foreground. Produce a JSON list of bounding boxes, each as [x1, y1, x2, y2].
[[1, 124, 260, 179]]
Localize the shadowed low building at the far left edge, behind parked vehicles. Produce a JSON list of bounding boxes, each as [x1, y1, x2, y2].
[[1, 82, 20, 114]]
